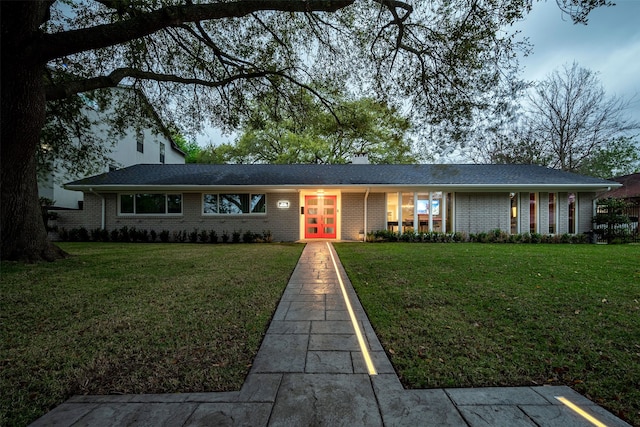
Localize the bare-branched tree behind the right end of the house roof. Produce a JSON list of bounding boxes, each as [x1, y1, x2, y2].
[[475, 63, 640, 171]]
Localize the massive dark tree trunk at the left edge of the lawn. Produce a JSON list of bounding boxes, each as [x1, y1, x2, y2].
[[0, 2, 65, 262]]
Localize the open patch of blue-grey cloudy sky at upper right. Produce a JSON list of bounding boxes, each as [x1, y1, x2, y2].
[[517, 0, 640, 121]]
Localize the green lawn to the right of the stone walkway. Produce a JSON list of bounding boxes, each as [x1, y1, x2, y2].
[[335, 243, 640, 425]]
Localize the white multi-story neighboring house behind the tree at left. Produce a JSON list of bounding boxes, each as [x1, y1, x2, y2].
[[38, 88, 185, 209]]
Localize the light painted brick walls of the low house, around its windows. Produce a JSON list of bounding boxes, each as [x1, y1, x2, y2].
[[52, 192, 595, 241]]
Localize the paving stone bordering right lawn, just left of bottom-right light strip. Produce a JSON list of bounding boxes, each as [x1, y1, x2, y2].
[[446, 387, 548, 405]]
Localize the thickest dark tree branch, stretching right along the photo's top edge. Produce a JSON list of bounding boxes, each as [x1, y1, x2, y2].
[[30, 0, 355, 63]]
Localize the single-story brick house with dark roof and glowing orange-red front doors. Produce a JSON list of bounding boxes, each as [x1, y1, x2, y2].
[[59, 164, 620, 241]]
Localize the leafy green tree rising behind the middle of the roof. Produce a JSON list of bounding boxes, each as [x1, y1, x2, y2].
[[218, 91, 415, 164]]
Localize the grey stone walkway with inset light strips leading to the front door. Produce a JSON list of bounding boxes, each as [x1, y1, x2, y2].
[[32, 242, 628, 427]]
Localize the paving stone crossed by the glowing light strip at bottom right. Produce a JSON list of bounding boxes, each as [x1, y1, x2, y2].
[[520, 405, 631, 427]]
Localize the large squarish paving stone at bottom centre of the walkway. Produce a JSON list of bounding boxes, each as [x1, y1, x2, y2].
[[269, 374, 382, 426]]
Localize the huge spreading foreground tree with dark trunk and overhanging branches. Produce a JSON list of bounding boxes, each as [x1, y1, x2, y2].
[[0, 0, 608, 261]]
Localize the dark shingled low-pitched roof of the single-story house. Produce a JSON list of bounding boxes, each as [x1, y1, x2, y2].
[[66, 164, 619, 190]]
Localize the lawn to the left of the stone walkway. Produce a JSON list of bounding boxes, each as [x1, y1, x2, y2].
[[0, 243, 303, 426]]
